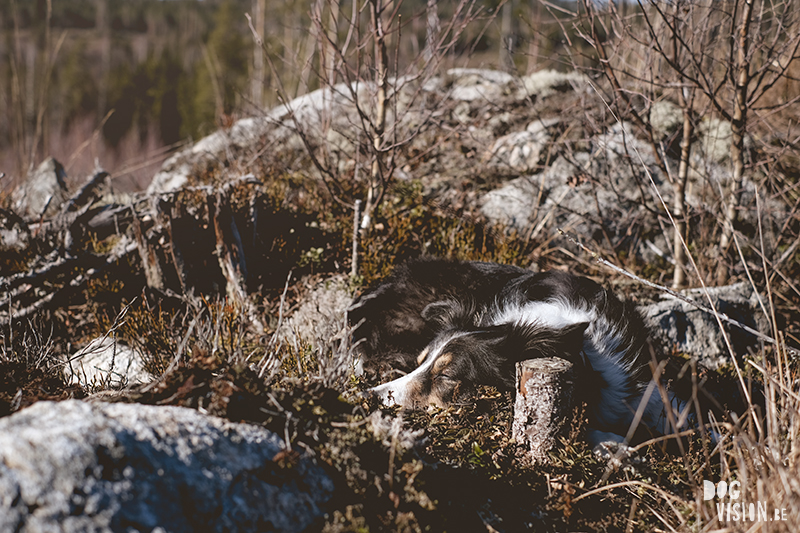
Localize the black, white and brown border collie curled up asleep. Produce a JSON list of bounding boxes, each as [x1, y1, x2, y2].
[[349, 258, 686, 444]]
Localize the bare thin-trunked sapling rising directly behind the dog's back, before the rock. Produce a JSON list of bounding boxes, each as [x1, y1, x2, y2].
[[251, 0, 491, 247]]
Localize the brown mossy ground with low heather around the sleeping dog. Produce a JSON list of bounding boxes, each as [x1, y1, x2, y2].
[[0, 163, 792, 532]]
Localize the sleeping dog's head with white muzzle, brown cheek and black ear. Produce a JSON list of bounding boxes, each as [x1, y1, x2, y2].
[[369, 311, 588, 409]]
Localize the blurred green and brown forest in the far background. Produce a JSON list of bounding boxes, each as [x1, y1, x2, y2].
[[0, 0, 576, 191]]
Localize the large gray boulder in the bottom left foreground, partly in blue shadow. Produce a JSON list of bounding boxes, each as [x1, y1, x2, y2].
[[0, 400, 334, 532]]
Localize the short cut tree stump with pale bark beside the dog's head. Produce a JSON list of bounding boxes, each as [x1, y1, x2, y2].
[[512, 357, 574, 463]]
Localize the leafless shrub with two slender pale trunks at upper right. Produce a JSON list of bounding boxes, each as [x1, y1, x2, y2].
[[575, 1, 800, 287]]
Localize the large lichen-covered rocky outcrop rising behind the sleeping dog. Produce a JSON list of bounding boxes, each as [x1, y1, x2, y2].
[[145, 68, 785, 263]]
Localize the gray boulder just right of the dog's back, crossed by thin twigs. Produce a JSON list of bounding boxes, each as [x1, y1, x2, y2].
[[639, 283, 769, 369]]
